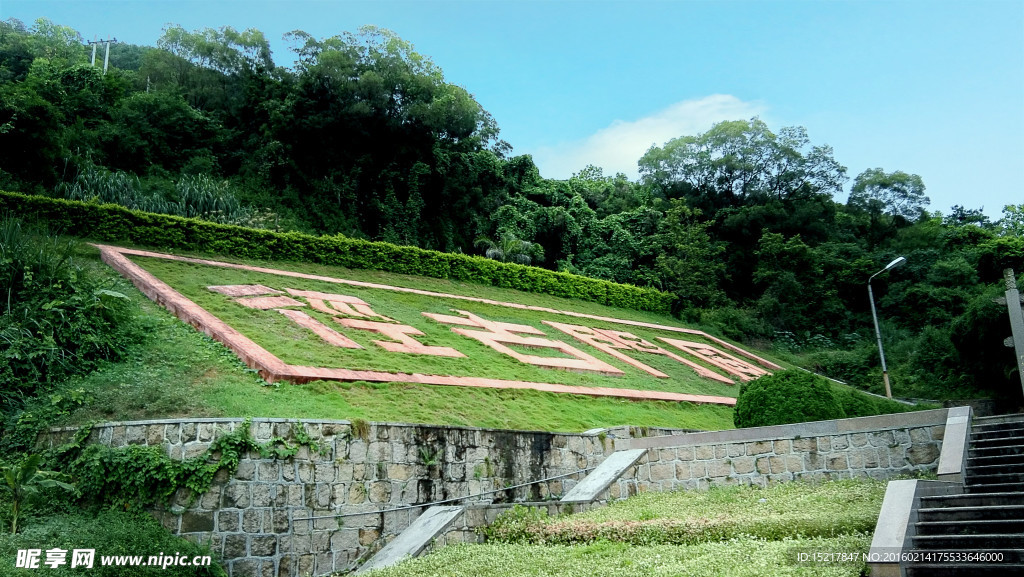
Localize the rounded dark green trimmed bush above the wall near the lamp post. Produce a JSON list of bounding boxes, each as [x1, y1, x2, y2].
[[732, 370, 846, 427]]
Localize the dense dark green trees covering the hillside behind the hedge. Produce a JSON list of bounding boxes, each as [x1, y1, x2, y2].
[[0, 15, 1024, 405]]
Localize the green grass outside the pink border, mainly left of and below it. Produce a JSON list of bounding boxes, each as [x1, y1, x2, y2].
[[49, 246, 733, 431]]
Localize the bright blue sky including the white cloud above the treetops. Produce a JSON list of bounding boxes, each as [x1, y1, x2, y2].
[[0, 0, 1024, 218]]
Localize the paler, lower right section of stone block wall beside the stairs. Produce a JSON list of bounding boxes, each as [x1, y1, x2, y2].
[[604, 409, 947, 500]]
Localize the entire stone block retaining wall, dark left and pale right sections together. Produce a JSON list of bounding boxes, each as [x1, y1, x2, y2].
[[43, 409, 947, 577]]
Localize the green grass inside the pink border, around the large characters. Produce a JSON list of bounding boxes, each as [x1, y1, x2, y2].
[[125, 253, 753, 397]]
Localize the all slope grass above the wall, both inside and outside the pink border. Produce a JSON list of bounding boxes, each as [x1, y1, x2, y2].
[[58, 247, 761, 430]]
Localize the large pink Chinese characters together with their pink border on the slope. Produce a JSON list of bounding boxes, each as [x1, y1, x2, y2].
[[99, 246, 778, 405]]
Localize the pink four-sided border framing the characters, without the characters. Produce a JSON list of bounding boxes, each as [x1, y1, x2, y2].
[[92, 244, 749, 406]]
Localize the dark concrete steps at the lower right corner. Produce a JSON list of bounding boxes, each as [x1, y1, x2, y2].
[[906, 414, 1024, 577]]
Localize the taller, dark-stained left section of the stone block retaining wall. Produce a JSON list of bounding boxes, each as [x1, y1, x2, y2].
[[39, 419, 614, 577]]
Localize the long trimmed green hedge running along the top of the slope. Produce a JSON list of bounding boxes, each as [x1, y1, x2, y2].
[[0, 191, 676, 313]]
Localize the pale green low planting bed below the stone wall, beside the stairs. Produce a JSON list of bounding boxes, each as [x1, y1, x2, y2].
[[360, 479, 886, 577]]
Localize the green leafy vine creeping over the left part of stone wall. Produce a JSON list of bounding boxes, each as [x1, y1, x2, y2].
[[47, 418, 330, 508]]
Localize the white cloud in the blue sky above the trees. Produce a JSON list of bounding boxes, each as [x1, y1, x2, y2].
[[524, 94, 764, 178]]
